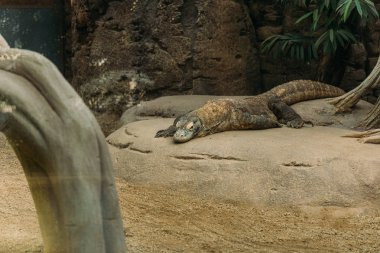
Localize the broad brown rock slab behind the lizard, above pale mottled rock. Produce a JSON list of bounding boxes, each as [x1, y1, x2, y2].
[[73, 0, 260, 99]]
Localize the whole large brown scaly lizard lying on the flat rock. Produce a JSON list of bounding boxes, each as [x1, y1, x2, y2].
[[155, 80, 344, 143]]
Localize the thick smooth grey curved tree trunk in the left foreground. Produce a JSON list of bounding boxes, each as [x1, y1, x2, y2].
[[0, 49, 126, 253]]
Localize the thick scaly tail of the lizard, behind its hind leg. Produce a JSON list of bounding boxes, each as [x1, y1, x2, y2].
[[267, 80, 345, 105]]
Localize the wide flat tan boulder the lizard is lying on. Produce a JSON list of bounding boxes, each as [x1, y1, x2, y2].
[[107, 100, 380, 207]]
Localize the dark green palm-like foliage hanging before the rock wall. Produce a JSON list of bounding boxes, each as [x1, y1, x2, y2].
[[261, 0, 379, 62]]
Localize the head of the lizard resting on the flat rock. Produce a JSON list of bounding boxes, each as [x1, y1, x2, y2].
[[173, 116, 202, 143]]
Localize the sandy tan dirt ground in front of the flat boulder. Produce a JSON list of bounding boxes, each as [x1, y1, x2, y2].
[[0, 136, 380, 253]]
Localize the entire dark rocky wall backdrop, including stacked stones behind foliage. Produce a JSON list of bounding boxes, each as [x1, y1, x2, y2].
[[69, 0, 380, 133]]
